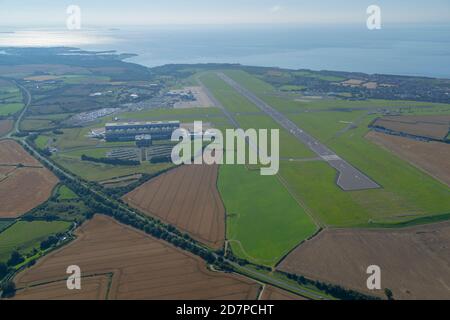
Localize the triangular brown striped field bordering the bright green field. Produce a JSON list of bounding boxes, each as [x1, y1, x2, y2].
[[124, 165, 225, 249]]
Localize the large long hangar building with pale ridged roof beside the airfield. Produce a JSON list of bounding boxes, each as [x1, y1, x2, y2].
[[105, 121, 180, 142]]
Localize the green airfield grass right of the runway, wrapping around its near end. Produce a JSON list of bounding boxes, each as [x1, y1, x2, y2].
[[225, 72, 450, 226]]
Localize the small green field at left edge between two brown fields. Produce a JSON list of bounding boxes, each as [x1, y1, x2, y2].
[[0, 221, 70, 262]]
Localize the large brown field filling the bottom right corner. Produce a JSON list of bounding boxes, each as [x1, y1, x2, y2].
[[279, 222, 450, 299]]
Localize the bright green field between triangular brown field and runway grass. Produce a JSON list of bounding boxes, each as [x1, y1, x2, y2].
[[218, 165, 316, 266]]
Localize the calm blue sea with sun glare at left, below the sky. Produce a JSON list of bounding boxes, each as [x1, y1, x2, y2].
[[0, 25, 450, 78]]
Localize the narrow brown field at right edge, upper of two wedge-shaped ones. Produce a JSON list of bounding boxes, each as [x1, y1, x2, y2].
[[373, 115, 450, 140]]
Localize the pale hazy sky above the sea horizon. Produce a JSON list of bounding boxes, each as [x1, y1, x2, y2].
[[0, 0, 450, 27]]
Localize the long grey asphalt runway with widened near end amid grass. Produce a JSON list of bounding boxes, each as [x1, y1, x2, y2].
[[217, 72, 380, 191]]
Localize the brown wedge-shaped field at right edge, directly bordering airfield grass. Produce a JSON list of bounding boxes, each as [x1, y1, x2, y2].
[[367, 131, 450, 187]]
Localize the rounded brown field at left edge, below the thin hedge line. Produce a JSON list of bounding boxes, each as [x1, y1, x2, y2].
[[0, 167, 58, 218]]
